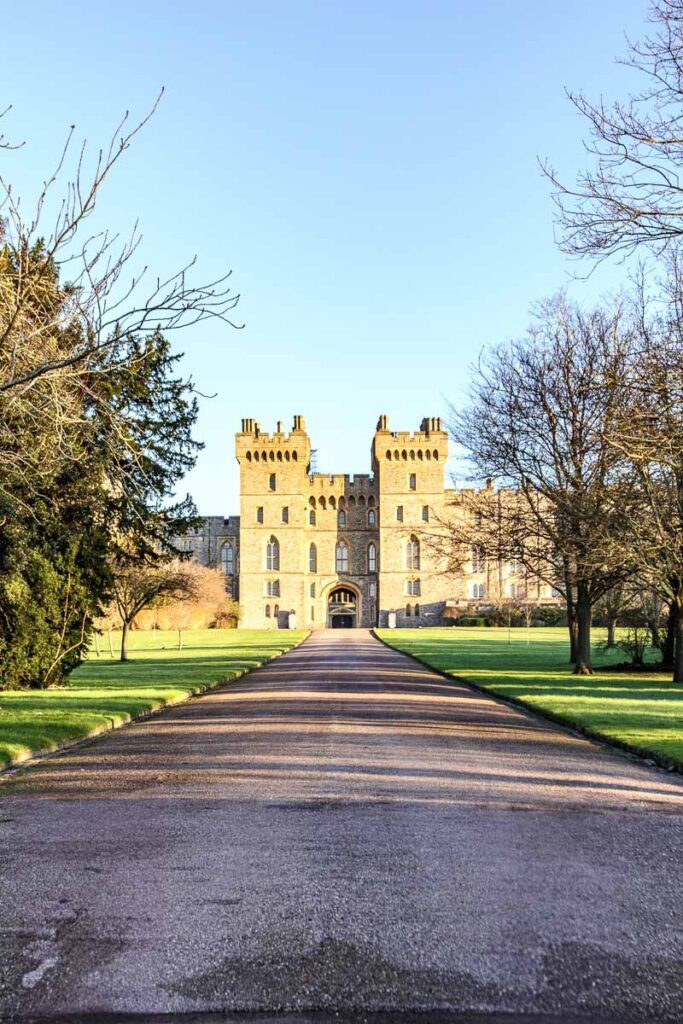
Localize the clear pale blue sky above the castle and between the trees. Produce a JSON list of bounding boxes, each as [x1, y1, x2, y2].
[[0, 0, 647, 514]]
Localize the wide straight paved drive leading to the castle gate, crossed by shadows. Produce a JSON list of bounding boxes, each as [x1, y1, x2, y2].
[[0, 631, 683, 1024]]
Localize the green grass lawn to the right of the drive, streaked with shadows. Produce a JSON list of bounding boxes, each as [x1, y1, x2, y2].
[[377, 627, 683, 767]]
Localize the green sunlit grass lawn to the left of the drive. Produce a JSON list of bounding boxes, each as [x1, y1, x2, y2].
[[0, 630, 306, 766]]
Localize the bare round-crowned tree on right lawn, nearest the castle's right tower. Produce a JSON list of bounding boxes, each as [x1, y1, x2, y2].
[[451, 295, 633, 674]]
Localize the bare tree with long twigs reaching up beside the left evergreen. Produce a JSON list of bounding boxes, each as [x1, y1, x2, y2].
[[0, 96, 239, 492]]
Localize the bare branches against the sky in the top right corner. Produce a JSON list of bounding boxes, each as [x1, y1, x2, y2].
[[543, 0, 683, 260]]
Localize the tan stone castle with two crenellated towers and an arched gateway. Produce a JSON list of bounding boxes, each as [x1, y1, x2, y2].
[[184, 416, 552, 629]]
